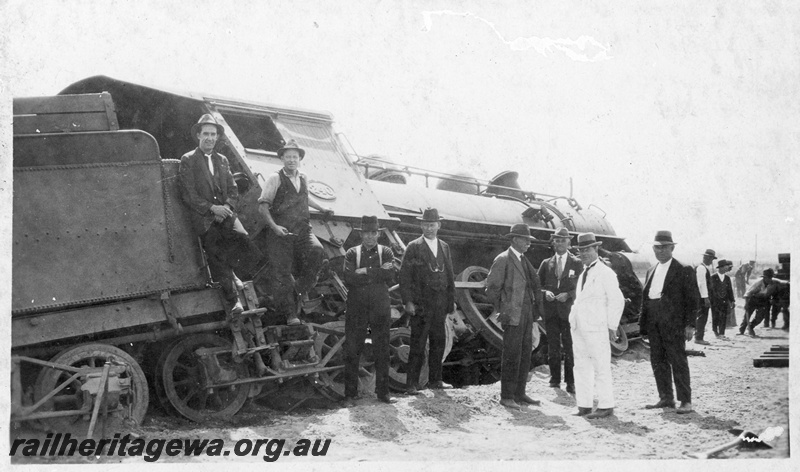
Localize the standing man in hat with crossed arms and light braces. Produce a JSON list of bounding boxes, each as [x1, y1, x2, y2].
[[344, 216, 395, 404]]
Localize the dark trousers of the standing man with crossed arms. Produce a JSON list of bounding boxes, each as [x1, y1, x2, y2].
[[344, 284, 391, 397]]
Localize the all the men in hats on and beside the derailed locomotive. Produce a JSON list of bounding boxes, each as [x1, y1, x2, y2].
[[179, 114, 777, 419]]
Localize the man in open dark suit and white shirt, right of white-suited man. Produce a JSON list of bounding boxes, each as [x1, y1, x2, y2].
[[639, 231, 700, 413]]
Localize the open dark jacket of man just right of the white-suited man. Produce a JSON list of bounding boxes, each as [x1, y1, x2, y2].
[[639, 259, 700, 335]]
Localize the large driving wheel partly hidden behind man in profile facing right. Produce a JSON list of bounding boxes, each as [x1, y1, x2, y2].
[[456, 266, 503, 349]]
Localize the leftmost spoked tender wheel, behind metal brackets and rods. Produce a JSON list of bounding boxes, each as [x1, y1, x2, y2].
[[34, 344, 150, 430]]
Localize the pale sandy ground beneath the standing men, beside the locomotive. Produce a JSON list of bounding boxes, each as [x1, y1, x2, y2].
[[12, 306, 789, 464]]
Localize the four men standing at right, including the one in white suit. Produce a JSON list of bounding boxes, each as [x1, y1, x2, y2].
[[486, 229, 699, 419]]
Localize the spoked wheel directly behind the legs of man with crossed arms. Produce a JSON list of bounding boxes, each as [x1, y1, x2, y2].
[[314, 321, 375, 401]]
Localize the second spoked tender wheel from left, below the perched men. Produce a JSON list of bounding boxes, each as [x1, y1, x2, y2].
[[159, 334, 250, 422]]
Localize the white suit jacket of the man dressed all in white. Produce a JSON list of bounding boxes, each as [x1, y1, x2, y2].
[[569, 259, 625, 337]]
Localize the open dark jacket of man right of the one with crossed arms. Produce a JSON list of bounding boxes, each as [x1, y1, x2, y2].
[[400, 236, 456, 313]]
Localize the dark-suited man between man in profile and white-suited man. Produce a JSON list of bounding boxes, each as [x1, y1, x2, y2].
[[539, 228, 583, 394]]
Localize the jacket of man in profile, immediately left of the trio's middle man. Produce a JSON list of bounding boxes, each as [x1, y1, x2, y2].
[[486, 248, 544, 326]]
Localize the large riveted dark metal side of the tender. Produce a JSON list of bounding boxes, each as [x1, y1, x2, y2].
[[12, 132, 205, 314]]
